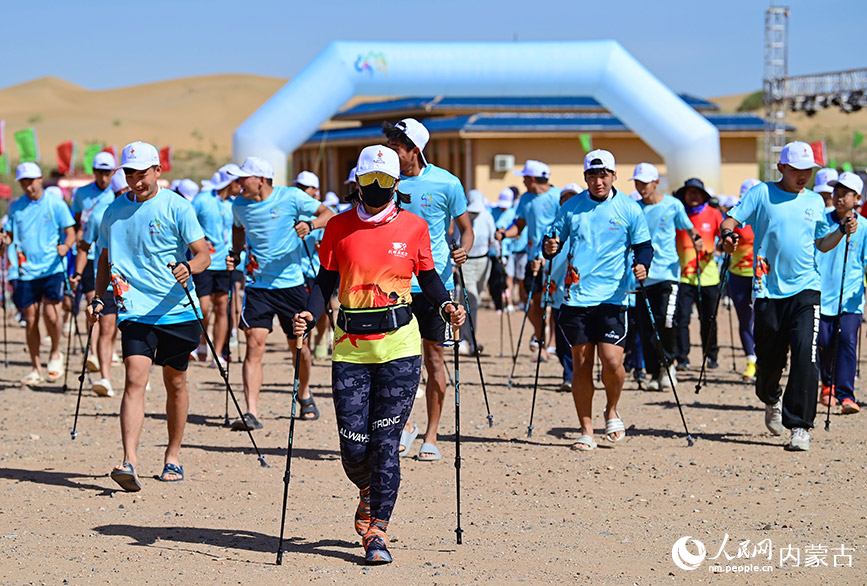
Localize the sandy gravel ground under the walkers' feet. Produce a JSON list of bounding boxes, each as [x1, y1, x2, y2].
[[0, 302, 867, 584]]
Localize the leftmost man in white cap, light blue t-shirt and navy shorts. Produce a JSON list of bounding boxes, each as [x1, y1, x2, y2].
[[4, 163, 75, 385]]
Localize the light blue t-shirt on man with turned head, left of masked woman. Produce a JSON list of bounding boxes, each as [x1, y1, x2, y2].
[[232, 186, 321, 289]]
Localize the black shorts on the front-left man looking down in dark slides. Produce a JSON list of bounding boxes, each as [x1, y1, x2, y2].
[[118, 320, 202, 371]]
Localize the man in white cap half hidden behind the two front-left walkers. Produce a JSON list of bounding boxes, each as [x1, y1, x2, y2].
[[193, 164, 241, 365]]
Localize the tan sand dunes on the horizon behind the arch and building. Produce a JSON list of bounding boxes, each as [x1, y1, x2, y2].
[[0, 74, 867, 176]]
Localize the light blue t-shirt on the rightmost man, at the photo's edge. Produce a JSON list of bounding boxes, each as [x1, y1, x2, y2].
[[816, 212, 867, 315]]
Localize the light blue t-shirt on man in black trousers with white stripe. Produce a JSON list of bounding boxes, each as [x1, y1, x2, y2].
[[728, 183, 835, 299]]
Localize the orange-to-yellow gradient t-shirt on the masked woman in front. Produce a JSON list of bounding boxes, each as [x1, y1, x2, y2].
[[319, 209, 435, 364]]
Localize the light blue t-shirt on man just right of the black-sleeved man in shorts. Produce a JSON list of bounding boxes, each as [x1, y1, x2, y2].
[[638, 195, 692, 285]]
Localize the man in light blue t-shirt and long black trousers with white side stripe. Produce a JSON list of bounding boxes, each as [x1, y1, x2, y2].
[[720, 141, 858, 451]]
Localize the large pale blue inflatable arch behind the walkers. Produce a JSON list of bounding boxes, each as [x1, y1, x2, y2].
[[233, 41, 720, 187]]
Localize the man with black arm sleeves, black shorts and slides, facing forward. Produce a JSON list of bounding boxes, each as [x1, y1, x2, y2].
[[544, 150, 653, 450]]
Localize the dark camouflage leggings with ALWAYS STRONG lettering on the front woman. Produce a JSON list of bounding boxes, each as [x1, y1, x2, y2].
[[331, 356, 421, 522]]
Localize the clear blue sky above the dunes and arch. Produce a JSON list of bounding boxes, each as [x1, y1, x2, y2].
[[0, 0, 867, 96]]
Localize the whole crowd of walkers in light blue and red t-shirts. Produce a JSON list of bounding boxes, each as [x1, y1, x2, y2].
[[3, 118, 867, 563]]
